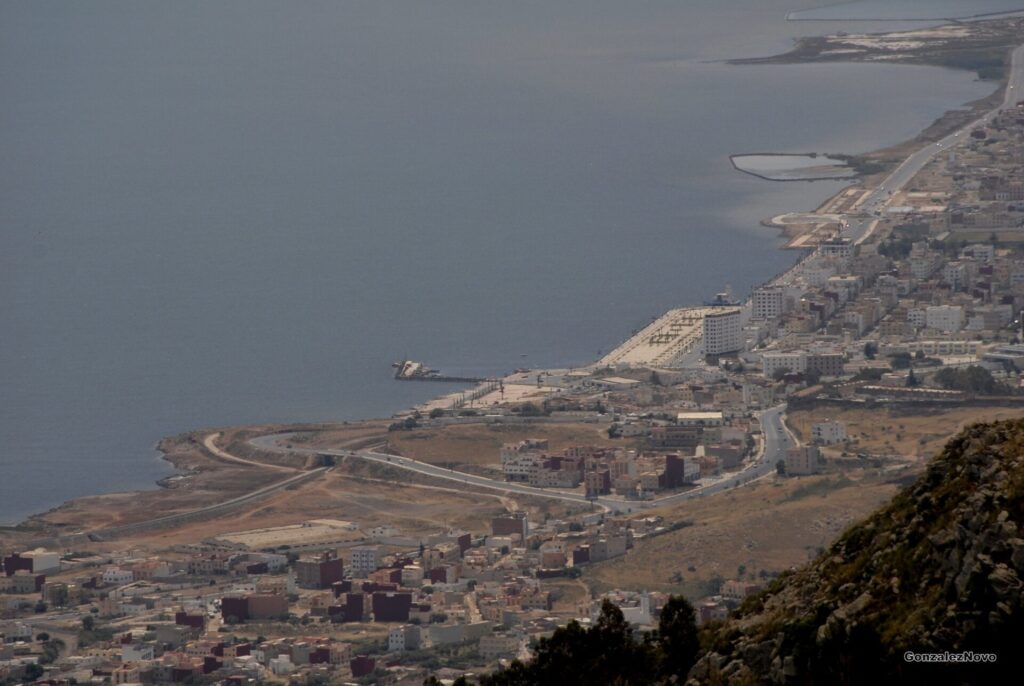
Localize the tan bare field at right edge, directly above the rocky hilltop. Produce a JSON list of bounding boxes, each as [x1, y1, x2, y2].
[[786, 406, 1024, 459]]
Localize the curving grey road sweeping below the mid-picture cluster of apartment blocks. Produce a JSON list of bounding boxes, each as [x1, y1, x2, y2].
[[250, 404, 793, 512]]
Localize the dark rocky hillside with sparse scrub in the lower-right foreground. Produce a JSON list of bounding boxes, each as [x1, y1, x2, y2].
[[689, 420, 1024, 685]]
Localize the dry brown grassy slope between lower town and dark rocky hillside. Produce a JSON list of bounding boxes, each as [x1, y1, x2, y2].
[[583, 472, 897, 599]]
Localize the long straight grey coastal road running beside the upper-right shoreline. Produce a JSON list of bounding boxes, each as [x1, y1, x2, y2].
[[846, 45, 1024, 244]]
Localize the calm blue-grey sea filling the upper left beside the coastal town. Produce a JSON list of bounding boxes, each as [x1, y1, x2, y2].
[[0, 0, 991, 522]]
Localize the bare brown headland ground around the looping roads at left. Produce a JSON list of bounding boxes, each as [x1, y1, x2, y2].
[[0, 413, 608, 551]]
